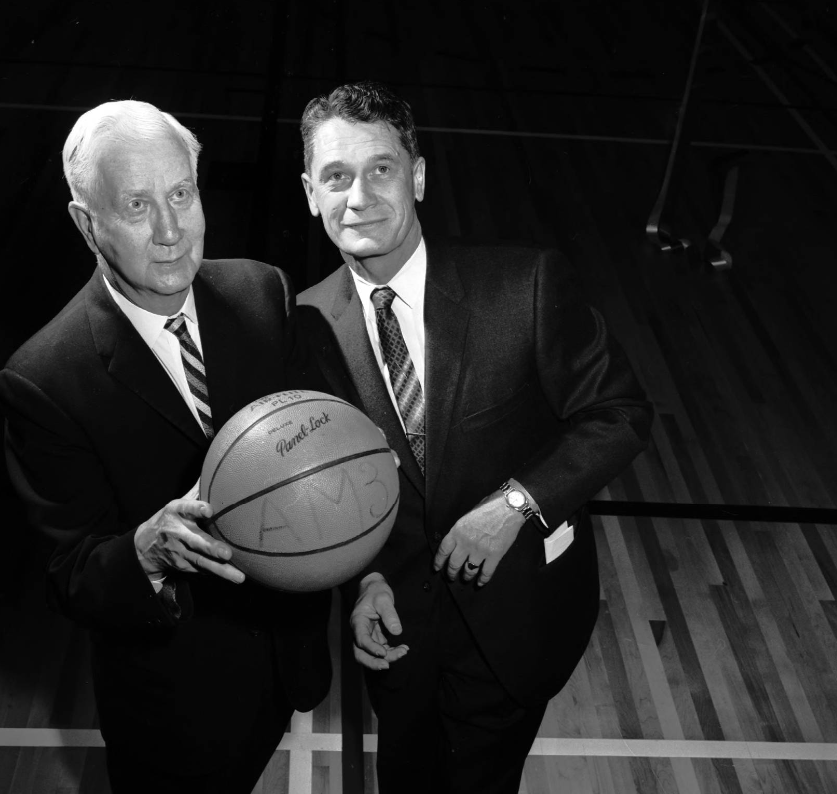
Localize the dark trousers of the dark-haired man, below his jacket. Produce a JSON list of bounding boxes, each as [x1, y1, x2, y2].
[[367, 588, 547, 794]]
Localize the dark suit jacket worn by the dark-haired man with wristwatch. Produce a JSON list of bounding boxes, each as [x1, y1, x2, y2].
[[298, 244, 652, 703]]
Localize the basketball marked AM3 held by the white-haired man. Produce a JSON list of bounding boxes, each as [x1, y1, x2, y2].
[[201, 391, 398, 592]]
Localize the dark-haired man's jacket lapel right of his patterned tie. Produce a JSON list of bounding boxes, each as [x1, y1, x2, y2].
[[424, 245, 470, 503]]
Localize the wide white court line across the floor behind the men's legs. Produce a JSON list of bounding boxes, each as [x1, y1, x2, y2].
[[0, 728, 837, 756]]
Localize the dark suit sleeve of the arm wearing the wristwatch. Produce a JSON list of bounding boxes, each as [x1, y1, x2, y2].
[[510, 252, 653, 527]]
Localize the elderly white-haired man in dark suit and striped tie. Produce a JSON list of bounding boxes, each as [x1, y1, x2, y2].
[[0, 101, 331, 794]]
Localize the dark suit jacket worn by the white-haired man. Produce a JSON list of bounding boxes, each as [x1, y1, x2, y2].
[[0, 260, 330, 763]]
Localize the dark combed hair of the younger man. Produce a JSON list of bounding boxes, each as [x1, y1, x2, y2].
[[300, 80, 420, 173]]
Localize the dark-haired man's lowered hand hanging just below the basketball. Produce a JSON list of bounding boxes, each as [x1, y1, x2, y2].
[[349, 573, 409, 670]]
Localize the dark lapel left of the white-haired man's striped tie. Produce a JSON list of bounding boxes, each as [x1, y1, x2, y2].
[[85, 269, 208, 447]]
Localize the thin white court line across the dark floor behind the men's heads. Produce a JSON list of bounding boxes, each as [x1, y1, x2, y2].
[[0, 102, 837, 156]]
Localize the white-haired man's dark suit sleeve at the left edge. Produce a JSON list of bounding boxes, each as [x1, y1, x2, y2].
[[0, 369, 176, 629]]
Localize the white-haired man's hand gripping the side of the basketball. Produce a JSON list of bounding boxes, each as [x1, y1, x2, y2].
[[134, 499, 244, 584]]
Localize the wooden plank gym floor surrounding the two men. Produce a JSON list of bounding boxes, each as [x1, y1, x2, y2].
[[0, 0, 837, 794]]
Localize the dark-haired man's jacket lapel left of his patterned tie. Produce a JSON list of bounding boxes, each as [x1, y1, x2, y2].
[[331, 265, 424, 495]]
